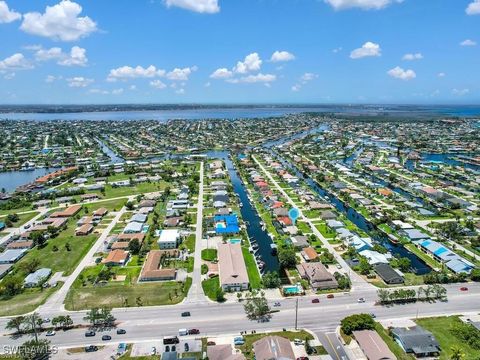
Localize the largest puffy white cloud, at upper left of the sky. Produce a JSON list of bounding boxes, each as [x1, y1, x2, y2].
[[20, 0, 97, 41]]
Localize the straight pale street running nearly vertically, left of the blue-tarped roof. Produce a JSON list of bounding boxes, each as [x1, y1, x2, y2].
[[185, 161, 207, 303]]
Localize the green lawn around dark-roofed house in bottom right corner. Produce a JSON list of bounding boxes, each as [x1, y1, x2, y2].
[[416, 316, 480, 360]]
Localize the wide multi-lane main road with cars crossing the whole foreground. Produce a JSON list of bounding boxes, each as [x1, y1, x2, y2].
[[0, 283, 480, 352]]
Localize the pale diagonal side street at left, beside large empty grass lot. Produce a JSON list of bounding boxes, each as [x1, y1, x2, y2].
[[39, 202, 133, 313]]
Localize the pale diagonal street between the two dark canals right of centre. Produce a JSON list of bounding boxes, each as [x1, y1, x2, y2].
[[253, 156, 374, 291]]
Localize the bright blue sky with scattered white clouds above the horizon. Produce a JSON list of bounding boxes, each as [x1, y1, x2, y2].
[[0, 0, 480, 104]]
